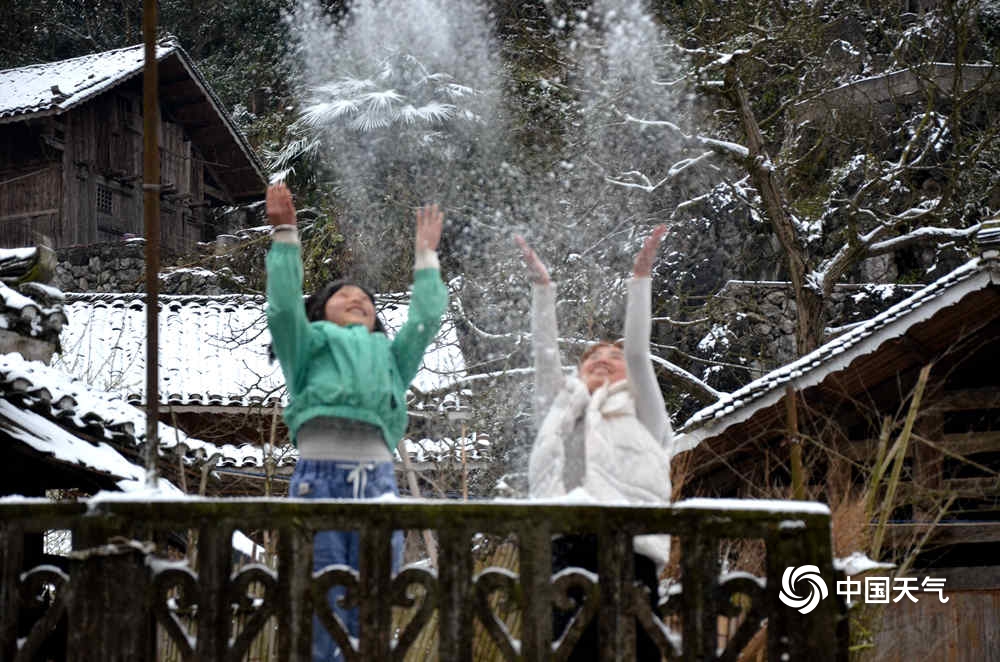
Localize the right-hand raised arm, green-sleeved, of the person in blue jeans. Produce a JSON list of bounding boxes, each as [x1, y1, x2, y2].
[[392, 204, 448, 384]]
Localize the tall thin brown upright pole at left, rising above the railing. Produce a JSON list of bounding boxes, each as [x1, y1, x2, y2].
[[142, 0, 160, 487]]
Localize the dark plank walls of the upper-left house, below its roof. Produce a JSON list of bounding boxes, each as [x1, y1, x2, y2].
[[0, 84, 210, 252]]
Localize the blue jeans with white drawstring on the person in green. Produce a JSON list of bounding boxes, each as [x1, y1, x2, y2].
[[288, 460, 403, 662]]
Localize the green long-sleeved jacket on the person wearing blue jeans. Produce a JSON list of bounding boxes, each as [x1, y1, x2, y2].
[[267, 242, 448, 451]]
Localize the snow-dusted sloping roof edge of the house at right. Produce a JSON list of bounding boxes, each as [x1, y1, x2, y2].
[[675, 254, 1000, 452]]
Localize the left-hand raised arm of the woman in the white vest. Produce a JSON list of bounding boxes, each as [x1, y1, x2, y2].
[[514, 235, 563, 424]]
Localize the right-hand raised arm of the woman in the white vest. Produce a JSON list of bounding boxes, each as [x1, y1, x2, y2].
[[625, 225, 673, 448]]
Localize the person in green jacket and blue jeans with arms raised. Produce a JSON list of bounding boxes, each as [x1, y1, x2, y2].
[[267, 184, 448, 662]]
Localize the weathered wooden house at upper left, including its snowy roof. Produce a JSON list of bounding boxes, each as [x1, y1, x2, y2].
[[0, 40, 266, 251]]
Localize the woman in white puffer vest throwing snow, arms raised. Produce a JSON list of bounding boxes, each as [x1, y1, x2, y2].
[[516, 225, 673, 660]]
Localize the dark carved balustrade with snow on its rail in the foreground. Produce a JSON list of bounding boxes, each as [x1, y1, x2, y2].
[[0, 499, 846, 662]]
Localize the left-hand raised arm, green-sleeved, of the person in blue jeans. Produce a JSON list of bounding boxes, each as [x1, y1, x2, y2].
[[266, 184, 309, 384]]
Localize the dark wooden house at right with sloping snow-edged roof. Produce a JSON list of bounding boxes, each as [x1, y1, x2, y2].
[[674, 226, 1000, 662]]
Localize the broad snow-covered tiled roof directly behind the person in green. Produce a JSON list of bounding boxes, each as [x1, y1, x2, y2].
[[57, 293, 465, 409]]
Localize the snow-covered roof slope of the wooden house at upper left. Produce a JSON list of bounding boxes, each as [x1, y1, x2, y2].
[[0, 42, 178, 122]]
